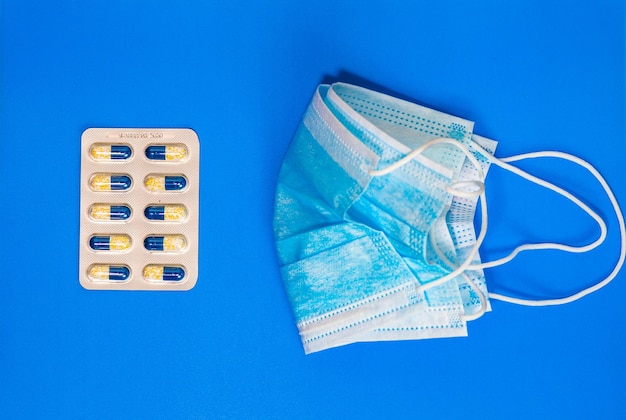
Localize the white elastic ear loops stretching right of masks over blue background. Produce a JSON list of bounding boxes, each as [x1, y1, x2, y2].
[[468, 144, 626, 306]]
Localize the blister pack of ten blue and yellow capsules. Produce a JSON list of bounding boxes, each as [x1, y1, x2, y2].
[[79, 128, 200, 290]]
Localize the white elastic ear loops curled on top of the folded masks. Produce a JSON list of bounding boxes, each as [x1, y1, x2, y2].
[[369, 137, 488, 320]]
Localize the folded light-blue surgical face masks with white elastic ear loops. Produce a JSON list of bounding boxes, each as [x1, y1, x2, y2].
[[274, 83, 626, 353]]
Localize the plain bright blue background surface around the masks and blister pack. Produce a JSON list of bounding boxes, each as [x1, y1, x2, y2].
[[0, 0, 626, 419]]
